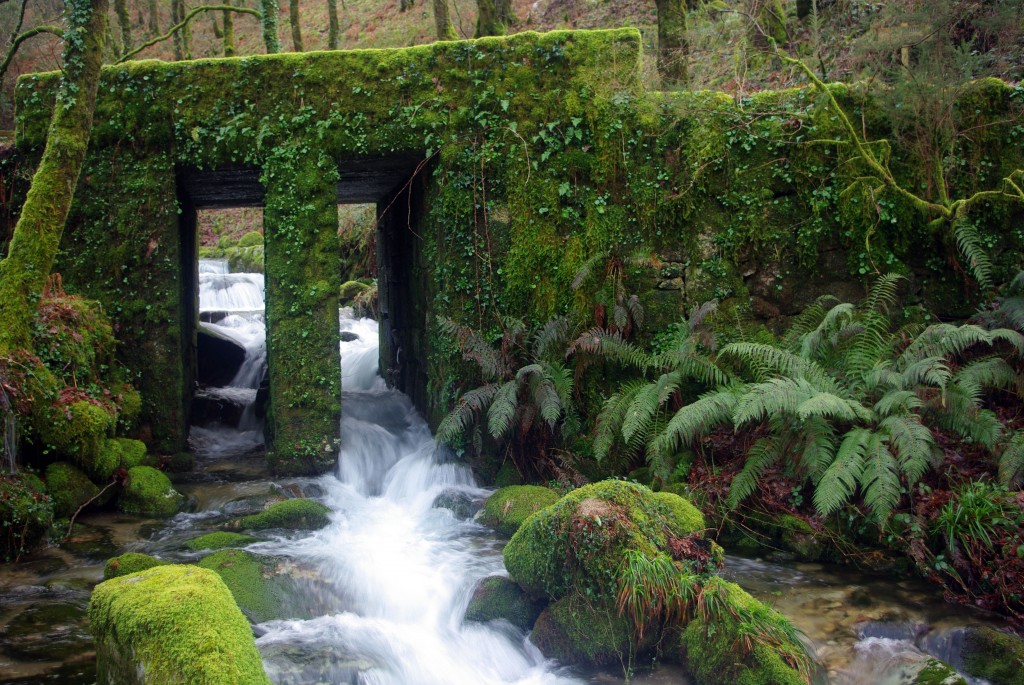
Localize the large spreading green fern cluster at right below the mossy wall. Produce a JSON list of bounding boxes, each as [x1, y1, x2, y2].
[[595, 274, 1024, 519]]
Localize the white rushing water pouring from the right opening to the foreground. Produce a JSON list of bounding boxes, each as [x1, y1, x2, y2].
[[257, 319, 579, 685]]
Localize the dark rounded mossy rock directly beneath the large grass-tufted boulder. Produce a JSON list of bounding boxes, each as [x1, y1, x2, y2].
[[529, 594, 637, 666]]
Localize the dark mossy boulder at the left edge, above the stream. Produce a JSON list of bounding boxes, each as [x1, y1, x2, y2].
[[0, 474, 53, 561]]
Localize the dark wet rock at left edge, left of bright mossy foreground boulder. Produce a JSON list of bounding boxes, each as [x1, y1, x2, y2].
[[0, 599, 92, 661]]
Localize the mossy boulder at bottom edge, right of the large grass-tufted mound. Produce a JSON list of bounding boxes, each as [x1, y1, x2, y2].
[[670, 577, 809, 685]]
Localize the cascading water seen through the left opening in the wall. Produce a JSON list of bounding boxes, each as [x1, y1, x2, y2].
[[189, 259, 266, 456]]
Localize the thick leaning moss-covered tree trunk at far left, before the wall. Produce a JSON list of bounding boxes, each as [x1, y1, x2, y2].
[[0, 0, 109, 356]]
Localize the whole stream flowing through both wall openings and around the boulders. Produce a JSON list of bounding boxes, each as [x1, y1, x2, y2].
[[0, 259, 1002, 685]]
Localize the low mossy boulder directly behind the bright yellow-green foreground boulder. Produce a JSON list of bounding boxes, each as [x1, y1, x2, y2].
[[197, 550, 287, 624]]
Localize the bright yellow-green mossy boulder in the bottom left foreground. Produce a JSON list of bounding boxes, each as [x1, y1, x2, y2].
[[89, 565, 270, 685]]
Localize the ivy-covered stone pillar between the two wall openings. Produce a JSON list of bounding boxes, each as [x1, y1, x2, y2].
[[262, 147, 341, 474]]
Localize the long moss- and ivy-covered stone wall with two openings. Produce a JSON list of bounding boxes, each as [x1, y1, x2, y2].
[[17, 30, 1024, 470]]
